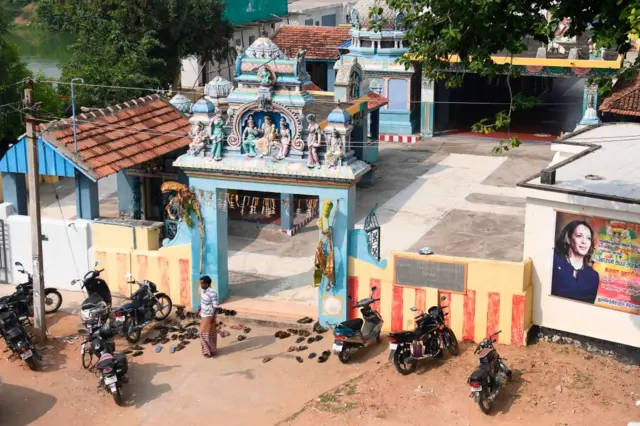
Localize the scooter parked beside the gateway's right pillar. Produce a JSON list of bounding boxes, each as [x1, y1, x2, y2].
[[333, 287, 384, 364]]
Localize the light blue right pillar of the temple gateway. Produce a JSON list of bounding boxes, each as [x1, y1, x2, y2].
[[318, 186, 356, 326]]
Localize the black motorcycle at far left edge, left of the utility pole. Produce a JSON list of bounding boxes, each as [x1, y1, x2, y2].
[[0, 303, 42, 371]]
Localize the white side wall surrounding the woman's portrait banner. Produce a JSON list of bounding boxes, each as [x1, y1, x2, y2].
[[524, 195, 640, 347]]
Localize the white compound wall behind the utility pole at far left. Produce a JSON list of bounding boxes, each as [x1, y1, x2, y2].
[[0, 203, 93, 291]]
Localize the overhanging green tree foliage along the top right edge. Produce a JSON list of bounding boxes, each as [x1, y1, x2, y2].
[[370, 0, 640, 150]]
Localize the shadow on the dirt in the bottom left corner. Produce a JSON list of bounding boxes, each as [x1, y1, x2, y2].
[[0, 383, 57, 426]]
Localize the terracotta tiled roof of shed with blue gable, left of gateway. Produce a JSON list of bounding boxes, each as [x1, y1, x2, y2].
[[40, 95, 191, 179]]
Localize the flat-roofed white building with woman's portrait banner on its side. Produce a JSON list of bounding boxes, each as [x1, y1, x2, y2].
[[519, 123, 640, 347]]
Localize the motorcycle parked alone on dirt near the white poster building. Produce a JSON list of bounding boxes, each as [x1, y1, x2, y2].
[[467, 331, 512, 414]]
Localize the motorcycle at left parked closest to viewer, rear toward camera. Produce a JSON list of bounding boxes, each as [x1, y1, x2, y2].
[[87, 324, 129, 405]]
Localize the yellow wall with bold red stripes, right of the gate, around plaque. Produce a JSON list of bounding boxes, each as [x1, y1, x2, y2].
[[348, 230, 533, 345]]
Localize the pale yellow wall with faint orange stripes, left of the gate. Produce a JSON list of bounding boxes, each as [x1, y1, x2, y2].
[[93, 223, 192, 308]]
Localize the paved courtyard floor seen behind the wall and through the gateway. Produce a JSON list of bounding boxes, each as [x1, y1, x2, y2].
[[32, 138, 552, 313]]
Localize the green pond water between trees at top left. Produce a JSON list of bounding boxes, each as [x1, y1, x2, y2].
[[7, 25, 75, 80]]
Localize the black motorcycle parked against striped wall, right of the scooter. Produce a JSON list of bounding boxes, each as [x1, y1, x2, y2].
[[389, 297, 460, 376]]
